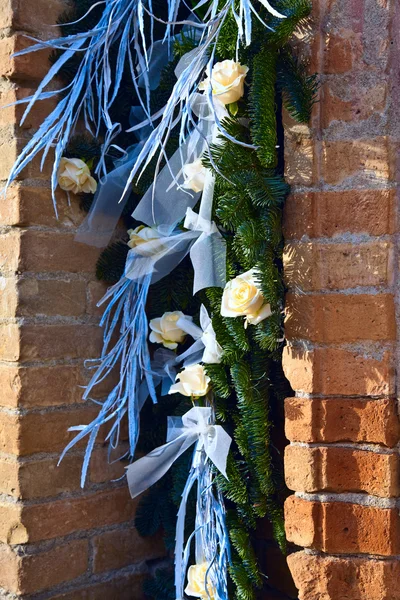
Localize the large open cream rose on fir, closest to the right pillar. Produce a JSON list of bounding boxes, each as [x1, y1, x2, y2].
[[221, 269, 272, 326]]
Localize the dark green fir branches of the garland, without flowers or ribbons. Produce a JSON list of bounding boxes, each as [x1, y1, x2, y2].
[[48, 0, 317, 600]]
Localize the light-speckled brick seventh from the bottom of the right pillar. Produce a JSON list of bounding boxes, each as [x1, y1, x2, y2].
[[284, 242, 393, 291]]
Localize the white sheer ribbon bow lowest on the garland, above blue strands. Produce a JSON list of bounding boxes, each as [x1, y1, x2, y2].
[[127, 406, 232, 498]]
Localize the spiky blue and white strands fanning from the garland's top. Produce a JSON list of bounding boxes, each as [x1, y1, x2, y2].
[[6, 0, 284, 213]]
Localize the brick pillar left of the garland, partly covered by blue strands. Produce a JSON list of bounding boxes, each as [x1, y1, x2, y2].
[[0, 0, 163, 600]]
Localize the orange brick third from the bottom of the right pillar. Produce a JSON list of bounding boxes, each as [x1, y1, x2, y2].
[[285, 446, 400, 498]]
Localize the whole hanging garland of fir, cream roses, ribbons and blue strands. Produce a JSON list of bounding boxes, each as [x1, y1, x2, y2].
[[10, 0, 316, 600]]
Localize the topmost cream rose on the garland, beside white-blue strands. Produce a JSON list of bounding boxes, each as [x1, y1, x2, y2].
[[199, 60, 249, 104]]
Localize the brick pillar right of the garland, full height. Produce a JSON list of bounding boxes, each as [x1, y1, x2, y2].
[[284, 0, 400, 600]]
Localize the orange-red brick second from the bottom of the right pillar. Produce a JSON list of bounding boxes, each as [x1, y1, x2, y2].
[[285, 496, 400, 556]]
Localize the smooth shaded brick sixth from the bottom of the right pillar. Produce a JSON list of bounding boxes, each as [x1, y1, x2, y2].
[[285, 293, 396, 344]]
